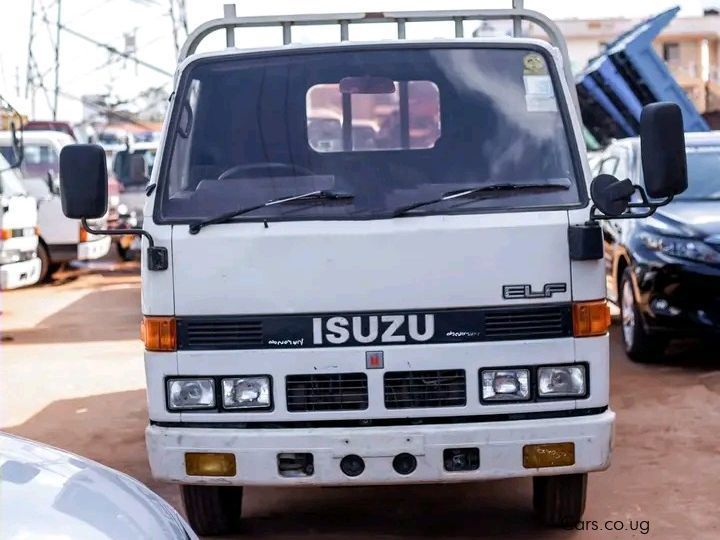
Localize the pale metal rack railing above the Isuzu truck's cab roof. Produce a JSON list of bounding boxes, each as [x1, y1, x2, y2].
[[178, 0, 579, 110]]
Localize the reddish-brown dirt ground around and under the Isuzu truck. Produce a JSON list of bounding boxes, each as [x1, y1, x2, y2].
[[0, 263, 720, 540]]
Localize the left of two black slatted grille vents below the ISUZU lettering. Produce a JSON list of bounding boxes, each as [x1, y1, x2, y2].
[[285, 373, 368, 412]]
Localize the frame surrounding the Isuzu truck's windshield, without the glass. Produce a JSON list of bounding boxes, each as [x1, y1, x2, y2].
[[153, 39, 590, 225]]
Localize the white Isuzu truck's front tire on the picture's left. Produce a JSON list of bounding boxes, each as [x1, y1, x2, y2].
[[181, 485, 243, 536]]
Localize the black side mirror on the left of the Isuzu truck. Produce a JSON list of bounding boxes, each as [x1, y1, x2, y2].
[[60, 144, 108, 219]]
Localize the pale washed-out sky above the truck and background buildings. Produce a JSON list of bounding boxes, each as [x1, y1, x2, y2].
[[0, 0, 720, 121]]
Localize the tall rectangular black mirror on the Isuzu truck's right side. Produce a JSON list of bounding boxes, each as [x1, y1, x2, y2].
[[640, 102, 687, 199]]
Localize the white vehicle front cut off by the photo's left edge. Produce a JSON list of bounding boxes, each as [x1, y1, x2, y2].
[[0, 155, 40, 290]]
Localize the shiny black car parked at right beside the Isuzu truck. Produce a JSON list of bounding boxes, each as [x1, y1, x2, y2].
[[594, 132, 720, 361]]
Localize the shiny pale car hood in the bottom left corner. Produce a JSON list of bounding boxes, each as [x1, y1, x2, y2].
[[0, 432, 197, 540]]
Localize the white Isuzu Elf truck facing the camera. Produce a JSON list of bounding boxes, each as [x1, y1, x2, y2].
[[54, 5, 687, 534]]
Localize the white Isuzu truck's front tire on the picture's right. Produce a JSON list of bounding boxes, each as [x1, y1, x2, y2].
[[533, 473, 587, 528]]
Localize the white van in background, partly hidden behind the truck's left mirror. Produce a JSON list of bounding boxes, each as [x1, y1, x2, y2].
[[0, 131, 110, 281]]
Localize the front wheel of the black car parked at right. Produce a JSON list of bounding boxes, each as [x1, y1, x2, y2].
[[620, 268, 667, 362]]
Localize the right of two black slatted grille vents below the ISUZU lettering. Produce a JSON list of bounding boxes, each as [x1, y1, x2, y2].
[[385, 369, 467, 409]]
